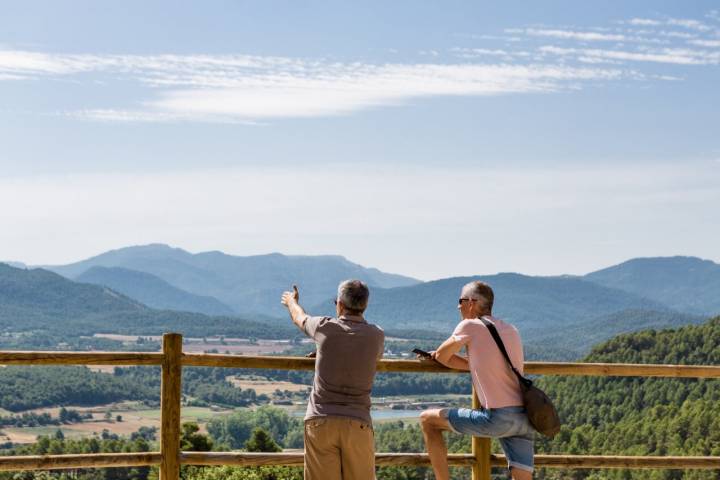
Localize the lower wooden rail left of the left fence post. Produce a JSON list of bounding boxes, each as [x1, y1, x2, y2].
[[0, 452, 161, 471]]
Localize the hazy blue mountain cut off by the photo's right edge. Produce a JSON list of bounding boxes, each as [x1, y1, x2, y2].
[[583, 257, 720, 316]]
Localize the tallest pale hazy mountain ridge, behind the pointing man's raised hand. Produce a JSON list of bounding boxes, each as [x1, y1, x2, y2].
[[46, 244, 419, 316]]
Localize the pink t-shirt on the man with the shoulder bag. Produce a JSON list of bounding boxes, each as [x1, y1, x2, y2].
[[453, 316, 523, 408]]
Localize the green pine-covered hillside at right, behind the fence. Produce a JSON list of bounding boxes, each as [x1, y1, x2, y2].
[[537, 317, 720, 479]]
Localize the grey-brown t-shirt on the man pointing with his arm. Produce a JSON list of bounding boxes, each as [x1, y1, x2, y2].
[[303, 315, 385, 423]]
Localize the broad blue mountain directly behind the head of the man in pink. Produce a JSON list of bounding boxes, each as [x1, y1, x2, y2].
[[309, 273, 705, 359]]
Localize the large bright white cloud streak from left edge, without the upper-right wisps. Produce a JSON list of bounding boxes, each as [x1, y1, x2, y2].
[[0, 51, 622, 122]]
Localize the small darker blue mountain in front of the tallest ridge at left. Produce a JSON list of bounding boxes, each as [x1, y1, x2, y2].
[[75, 267, 234, 315]]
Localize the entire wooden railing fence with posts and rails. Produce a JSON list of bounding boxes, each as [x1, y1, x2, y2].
[[0, 333, 720, 480]]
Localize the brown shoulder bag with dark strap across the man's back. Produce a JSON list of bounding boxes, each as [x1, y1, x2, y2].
[[480, 318, 560, 438]]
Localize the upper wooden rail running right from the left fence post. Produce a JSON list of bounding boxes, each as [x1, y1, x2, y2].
[[182, 353, 720, 378]]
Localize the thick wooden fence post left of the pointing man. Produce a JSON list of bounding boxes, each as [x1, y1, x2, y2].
[[160, 333, 182, 480]]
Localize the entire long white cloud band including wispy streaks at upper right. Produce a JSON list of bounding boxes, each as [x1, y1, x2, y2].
[[0, 12, 720, 124]]
